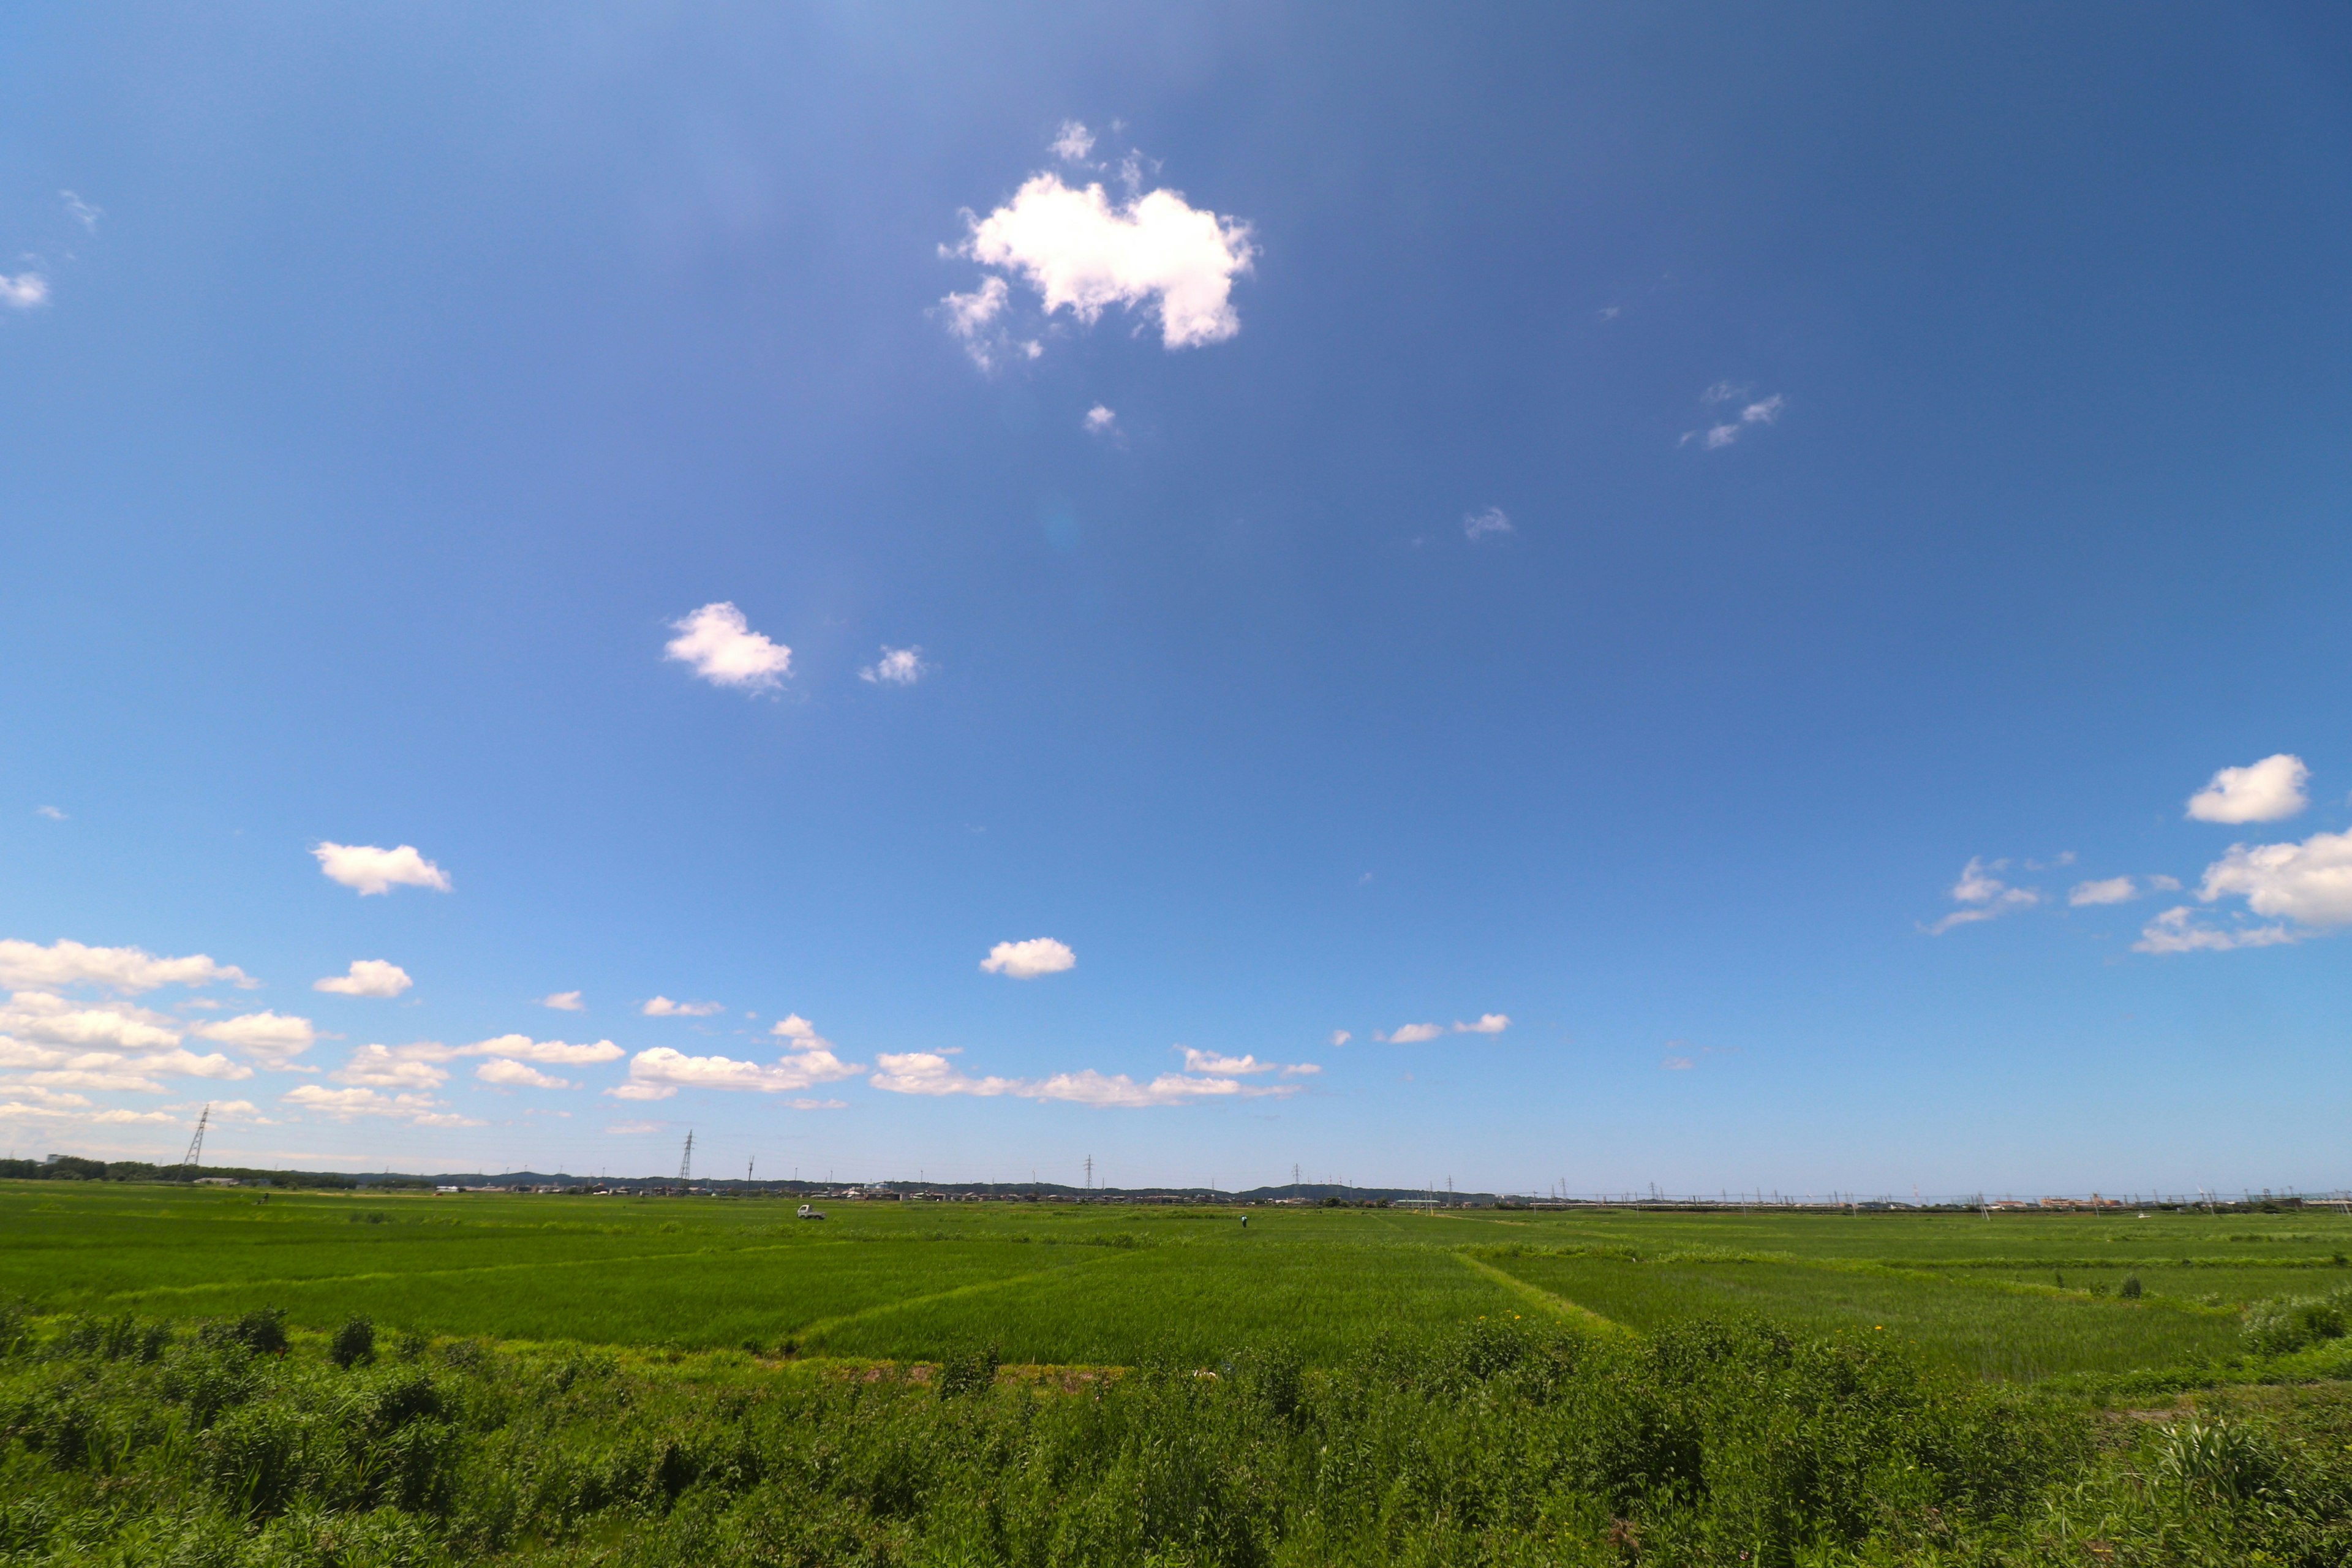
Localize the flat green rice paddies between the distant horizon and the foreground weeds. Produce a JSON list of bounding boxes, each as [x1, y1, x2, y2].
[[0, 1183, 2352, 1380]]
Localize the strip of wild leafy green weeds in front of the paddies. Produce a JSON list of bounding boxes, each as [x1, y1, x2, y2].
[[0, 1314, 2352, 1568]]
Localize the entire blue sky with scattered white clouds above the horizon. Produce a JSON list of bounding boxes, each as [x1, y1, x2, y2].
[[0, 5, 2352, 1192]]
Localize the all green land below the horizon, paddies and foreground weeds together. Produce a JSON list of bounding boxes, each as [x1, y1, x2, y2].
[[0, 1180, 2352, 1568]]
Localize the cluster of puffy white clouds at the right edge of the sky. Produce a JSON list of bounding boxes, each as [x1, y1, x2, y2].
[[1921, 752, 2352, 954]]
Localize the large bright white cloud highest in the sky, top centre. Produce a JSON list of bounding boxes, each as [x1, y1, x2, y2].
[[943, 172, 1256, 348]]
